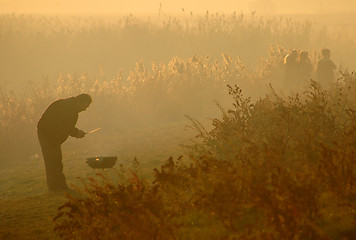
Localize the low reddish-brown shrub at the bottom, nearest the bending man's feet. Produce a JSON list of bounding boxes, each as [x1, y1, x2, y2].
[[55, 160, 186, 239]]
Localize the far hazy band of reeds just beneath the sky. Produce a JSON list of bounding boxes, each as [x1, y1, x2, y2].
[[0, 13, 356, 86]]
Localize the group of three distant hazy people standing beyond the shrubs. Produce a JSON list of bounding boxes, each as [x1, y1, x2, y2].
[[284, 48, 336, 89]]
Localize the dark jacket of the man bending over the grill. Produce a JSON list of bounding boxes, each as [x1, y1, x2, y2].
[[37, 97, 79, 144]]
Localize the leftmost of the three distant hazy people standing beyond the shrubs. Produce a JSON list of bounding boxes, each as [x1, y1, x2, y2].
[[283, 50, 299, 88]]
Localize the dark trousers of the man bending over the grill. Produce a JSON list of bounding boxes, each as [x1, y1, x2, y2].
[[37, 131, 68, 191]]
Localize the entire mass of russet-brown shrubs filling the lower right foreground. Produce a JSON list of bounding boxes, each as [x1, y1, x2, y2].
[[55, 74, 356, 239]]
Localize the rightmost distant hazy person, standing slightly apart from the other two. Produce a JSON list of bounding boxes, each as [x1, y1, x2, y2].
[[316, 48, 336, 85]]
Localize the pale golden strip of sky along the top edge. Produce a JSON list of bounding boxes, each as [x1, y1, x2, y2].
[[0, 0, 356, 14]]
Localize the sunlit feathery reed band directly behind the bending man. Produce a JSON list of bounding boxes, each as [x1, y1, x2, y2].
[[0, 47, 285, 164]]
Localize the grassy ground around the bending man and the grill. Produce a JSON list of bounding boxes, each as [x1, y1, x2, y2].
[[0, 122, 196, 240]]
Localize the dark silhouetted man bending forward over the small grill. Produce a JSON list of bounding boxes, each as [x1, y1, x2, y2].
[[37, 94, 92, 191]]
